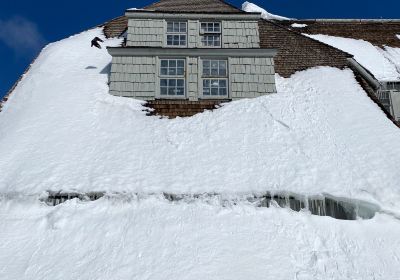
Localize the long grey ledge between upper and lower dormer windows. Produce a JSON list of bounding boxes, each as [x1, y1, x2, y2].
[[107, 47, 278, 57]]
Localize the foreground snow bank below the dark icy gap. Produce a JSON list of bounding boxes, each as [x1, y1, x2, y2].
[[0, 198, 400, 280]]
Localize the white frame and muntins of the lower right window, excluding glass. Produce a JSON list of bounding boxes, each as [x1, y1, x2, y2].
[[199, 57, 230, 99]]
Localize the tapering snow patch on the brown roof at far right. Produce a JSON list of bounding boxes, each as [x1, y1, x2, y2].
[[304, 34, 400, 81]]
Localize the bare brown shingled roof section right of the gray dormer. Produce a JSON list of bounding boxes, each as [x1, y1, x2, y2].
[[259, 20, 351, 77]]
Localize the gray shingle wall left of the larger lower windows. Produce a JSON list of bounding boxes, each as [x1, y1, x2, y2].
[[110, 57, 157, 100]]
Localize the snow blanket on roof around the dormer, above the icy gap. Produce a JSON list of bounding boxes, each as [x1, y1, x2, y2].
[[0, 29, 400, 212]]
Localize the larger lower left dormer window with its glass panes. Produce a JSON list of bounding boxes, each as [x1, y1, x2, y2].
[[160, 59, 185, 97]]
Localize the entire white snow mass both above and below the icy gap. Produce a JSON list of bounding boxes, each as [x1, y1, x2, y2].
[[0, 26, 400, 280]]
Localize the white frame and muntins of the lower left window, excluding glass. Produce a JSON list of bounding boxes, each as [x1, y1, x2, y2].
[[156, 57, 187, 99]]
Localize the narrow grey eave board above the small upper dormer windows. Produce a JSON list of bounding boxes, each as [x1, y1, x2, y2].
[[125, 10, 261, 20]]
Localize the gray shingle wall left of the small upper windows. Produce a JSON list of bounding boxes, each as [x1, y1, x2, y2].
[[126, 19, 164, 47]]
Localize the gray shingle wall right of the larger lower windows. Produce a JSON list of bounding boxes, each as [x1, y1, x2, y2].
[[229, 57, 276, 99]]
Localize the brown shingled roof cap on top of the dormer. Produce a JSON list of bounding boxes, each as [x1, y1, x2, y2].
[[144, 0, 243, 13]]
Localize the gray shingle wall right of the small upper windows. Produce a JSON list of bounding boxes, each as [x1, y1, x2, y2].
[[222, 21, 260, 48]]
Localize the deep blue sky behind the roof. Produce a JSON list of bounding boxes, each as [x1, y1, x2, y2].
[[0, 0, 400, 97]]
